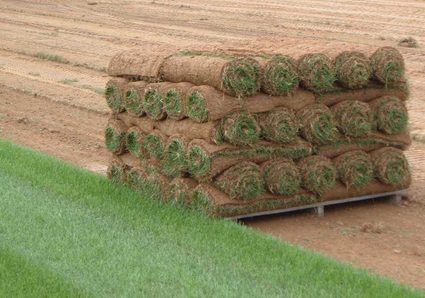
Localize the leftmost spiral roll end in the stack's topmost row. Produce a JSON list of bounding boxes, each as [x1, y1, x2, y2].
[[222, 58, 260, 97]]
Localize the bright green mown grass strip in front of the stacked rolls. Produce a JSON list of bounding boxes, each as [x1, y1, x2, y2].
[[0, 141, 423, 297]]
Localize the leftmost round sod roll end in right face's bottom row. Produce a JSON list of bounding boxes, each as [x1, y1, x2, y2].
[[215, 161, 265, 200]]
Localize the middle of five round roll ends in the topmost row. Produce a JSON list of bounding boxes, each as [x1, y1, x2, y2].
[[298, 53, 336, 94]]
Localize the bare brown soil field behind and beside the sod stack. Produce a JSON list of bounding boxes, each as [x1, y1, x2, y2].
[[0, 0, 425, 289]]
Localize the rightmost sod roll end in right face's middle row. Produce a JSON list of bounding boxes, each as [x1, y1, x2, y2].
[[370, 96, 408, 135]]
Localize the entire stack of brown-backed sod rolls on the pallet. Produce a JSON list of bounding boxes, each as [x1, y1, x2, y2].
[[105, 47, 411, 217]]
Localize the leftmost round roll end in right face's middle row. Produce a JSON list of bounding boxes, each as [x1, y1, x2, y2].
[[220, 112, 261, 146]]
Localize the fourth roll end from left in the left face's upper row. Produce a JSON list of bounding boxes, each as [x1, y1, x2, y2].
[[163, 82, 193, 120]]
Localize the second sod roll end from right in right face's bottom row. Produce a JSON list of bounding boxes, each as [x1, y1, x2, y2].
[[334, 150, 374, 189]]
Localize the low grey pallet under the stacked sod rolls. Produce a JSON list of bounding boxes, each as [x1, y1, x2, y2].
[[228, 189, 407, 220]]
